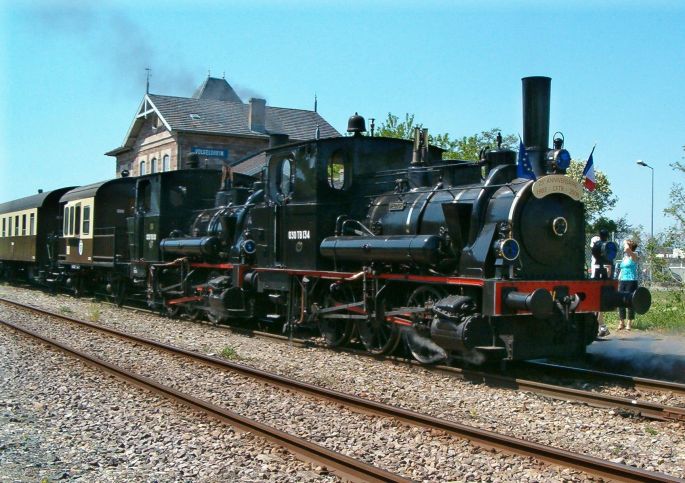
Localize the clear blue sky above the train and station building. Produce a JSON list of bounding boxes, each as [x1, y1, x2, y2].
[[0, 0, 685, 231]]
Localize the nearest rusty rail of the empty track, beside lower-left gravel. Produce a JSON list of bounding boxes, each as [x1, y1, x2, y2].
[[0, 319, 411, 482]]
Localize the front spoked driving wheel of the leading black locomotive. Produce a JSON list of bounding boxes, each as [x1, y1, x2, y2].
[[402, 285, 447, 364]]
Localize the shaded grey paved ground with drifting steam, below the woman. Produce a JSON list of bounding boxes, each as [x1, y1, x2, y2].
[[588, 333, 685, 382]]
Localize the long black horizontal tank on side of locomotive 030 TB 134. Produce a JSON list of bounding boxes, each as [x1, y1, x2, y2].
[[320, 235, 440, 265]]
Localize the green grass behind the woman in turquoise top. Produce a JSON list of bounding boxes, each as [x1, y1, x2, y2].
[[604, 286, 685, 334]]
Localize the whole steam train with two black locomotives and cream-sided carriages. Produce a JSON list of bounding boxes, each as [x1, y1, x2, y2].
[[0, 77, 651, 363]]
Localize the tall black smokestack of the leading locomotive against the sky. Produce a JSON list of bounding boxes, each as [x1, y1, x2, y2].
[[521, 77, 552, 176]]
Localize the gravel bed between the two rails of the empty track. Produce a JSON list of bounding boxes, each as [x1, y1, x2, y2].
[[4, 296, 585, 481]]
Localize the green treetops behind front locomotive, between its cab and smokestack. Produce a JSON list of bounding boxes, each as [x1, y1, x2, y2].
[[376, 113, 518, 161]]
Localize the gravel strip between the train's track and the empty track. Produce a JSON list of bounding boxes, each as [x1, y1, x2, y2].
[[0, 286, 685, 480]]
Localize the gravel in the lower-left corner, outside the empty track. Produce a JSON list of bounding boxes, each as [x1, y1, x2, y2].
[[0, 328, 337, 482]]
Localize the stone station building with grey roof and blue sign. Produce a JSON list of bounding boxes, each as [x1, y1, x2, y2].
[[105, 77, 340, 177]]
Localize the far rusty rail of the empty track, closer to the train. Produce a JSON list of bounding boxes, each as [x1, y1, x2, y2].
[[0, 299, 679, 481]]
